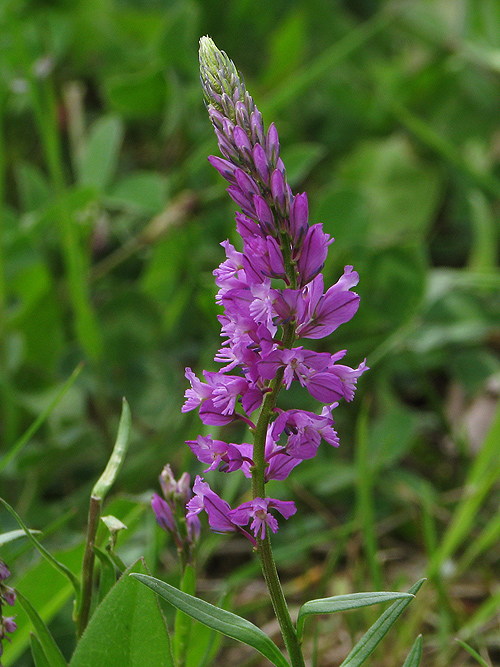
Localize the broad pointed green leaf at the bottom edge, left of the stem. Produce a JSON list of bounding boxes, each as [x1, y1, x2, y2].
[[70, 561, 174, 667]]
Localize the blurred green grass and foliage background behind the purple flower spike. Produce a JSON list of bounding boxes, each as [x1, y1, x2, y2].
[[0, 0, 500, 667]]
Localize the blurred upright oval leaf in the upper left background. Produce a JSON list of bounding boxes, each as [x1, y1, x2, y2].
[[79, 115, 123, 192]]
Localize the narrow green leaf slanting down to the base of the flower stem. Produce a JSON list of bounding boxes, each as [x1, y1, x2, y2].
[[131, 574, 290, 667]]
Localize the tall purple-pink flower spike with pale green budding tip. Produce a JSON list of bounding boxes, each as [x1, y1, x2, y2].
[[177, 37, 366, 544]]
